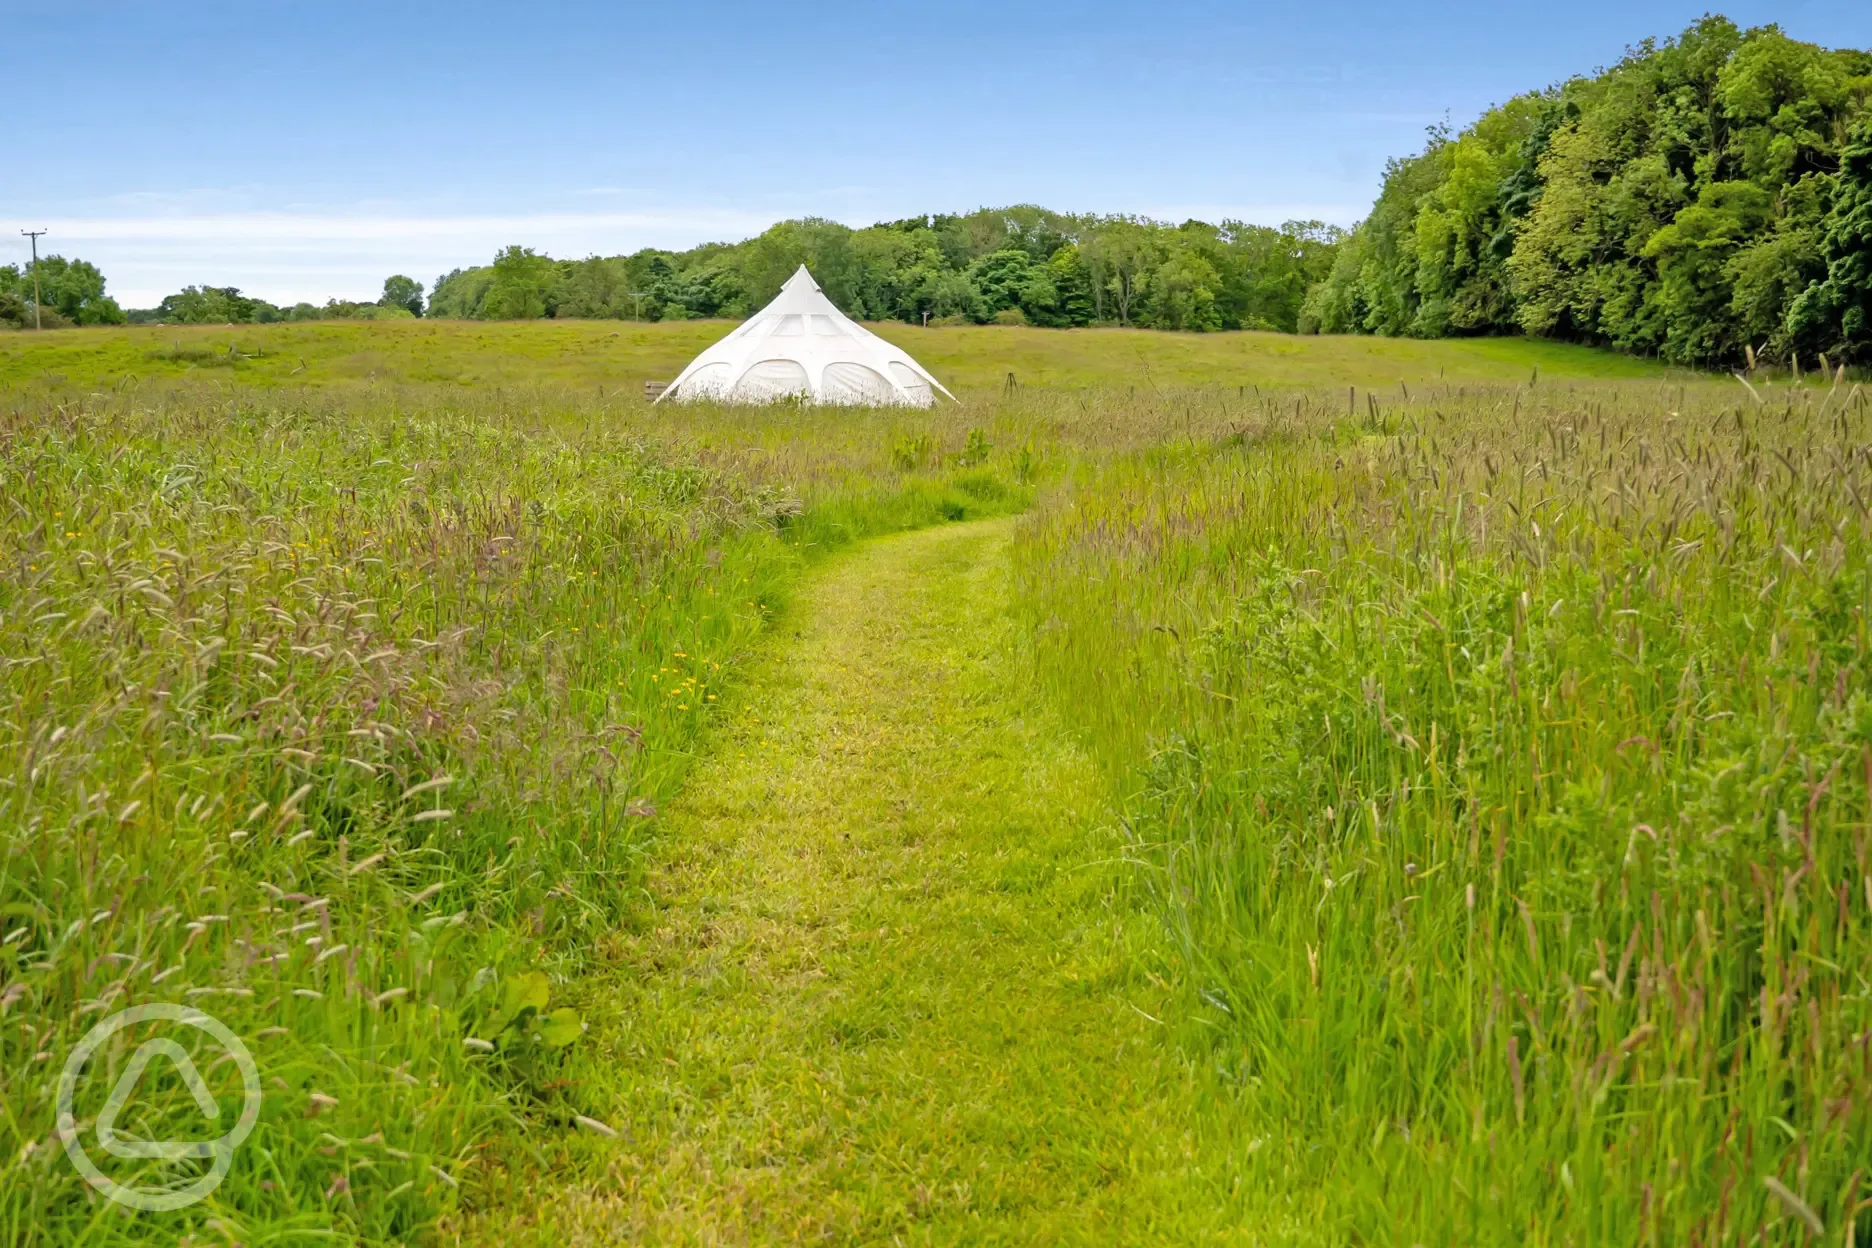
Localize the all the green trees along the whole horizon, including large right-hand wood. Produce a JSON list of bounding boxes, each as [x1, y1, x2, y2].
[[0, 17, 1872, 367]]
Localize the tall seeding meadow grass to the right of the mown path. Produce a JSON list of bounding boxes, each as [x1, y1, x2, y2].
[[1018, 387, 1872, 1244]]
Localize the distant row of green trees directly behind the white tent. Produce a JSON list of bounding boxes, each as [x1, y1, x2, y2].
[[429, 204, 1340, 331]]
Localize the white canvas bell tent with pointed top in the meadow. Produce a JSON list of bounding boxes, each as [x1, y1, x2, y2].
[[657, 264, 955, 408]]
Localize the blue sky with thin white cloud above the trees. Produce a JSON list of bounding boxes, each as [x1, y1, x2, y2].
[[14, 0, 1872, 307]]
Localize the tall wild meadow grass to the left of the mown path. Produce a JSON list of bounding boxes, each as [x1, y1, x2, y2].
[[0, 387, 1024, 1242]]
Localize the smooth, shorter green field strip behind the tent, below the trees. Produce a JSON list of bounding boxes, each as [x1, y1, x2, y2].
[[0, 320, 1666, 391]]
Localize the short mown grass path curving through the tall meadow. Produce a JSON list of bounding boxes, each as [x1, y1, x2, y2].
[[479, 520, 1239, 1244]]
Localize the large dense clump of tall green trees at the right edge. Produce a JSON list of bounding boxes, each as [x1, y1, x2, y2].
[[1301, 17, 1872, 367]]
